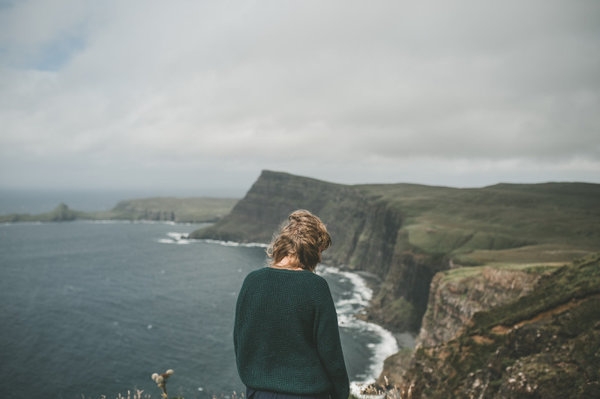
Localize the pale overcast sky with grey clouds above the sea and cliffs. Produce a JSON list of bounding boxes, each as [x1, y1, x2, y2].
[[0, 0, 600, 197]]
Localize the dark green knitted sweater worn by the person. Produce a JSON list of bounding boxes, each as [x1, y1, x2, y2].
[[233, 267, 349, 399]]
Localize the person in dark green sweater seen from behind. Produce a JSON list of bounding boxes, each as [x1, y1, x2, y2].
[[233, 210, 349, 399]]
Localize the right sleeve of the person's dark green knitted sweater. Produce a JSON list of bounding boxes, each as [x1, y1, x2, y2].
[[315, 283, 350, 399]]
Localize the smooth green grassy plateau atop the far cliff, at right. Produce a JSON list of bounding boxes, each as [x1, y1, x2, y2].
[[361, 183, 600, 265]]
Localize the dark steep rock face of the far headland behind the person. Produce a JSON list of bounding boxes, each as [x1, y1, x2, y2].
[[190, 171, 440, 331]]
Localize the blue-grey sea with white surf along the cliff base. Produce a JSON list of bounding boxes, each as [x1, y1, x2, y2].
[[0, 221, 397, 399]]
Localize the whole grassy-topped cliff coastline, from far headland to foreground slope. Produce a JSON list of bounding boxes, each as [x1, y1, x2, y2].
[[192, 171, 600, 398]]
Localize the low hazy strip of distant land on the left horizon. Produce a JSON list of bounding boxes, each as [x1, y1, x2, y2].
[[0, 197, 239, 223]]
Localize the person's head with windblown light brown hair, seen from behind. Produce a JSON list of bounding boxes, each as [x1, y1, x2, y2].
[[267, 209, 331, 271]]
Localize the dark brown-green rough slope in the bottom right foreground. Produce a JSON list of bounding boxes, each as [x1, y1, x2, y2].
[[394, 255, 600, 398]]
